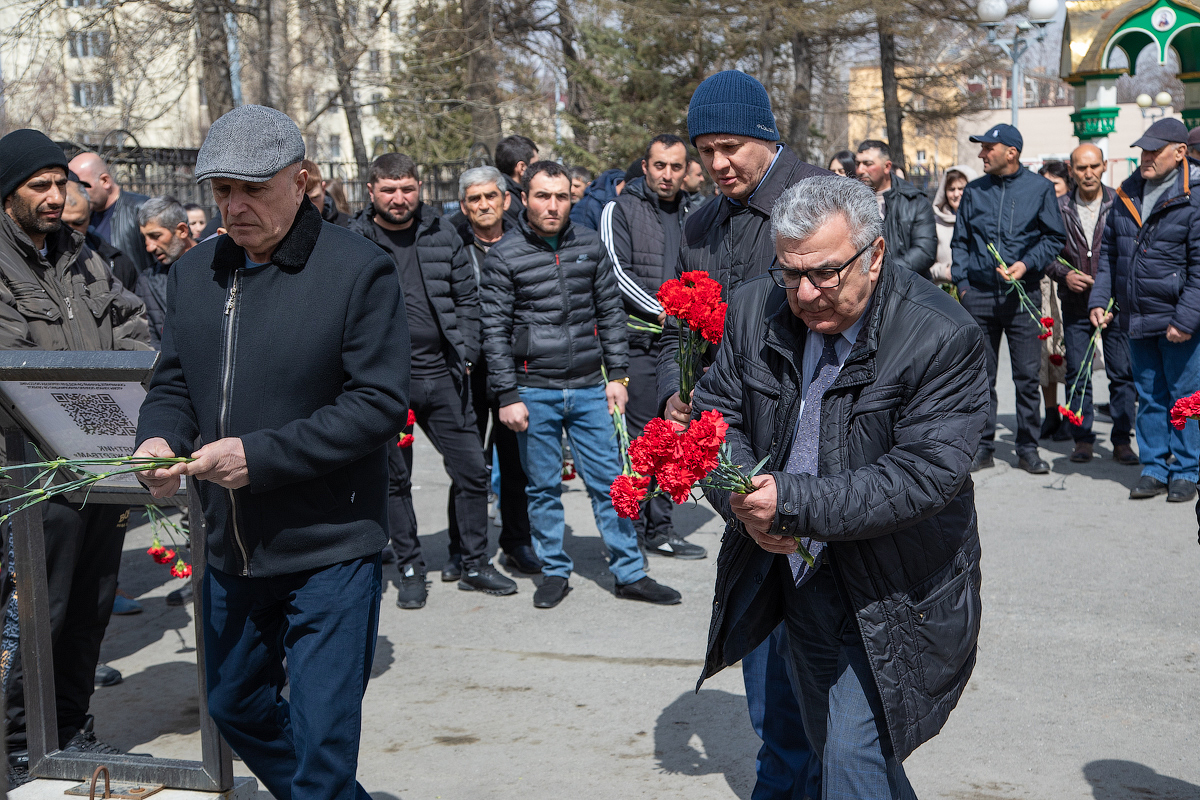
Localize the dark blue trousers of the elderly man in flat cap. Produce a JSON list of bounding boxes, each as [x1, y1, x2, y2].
[[204, 555, 383, 800]]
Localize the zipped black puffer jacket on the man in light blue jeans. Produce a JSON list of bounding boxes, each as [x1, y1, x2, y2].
[[482, 216, 629, 405]]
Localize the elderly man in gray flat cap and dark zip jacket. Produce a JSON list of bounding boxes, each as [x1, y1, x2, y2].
[[137, 106, 409, 800]]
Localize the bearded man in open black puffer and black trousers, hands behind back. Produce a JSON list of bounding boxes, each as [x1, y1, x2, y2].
[[350, 152, 517, 608]]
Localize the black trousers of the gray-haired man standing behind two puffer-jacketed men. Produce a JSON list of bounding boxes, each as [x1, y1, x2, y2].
[[450, 362, 533, 553]]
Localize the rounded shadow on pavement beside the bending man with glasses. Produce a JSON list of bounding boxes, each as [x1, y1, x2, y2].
[[654, 690, 762, 800]]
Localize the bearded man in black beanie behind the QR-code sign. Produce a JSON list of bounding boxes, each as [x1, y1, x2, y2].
[[0, 130, 150, 783]]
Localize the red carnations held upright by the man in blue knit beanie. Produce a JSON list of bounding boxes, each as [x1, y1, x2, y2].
[[658, 270, 728, 403]]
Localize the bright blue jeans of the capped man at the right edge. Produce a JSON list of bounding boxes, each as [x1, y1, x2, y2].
[[1128, 336, 1200, 483]]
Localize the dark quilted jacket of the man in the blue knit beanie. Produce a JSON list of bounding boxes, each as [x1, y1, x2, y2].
[[658, 145, 832, 410]]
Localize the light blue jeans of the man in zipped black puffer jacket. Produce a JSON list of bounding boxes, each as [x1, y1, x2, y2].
[[517, 386, 646, 585]]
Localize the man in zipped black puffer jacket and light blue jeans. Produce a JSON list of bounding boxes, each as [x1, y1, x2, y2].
[[482, 161, 679, 608]]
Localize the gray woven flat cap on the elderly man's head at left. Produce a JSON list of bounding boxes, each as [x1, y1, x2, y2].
[[196, 106, 304, 184]]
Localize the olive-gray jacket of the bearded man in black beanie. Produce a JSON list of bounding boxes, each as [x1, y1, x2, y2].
[[0, 212, 151, 350]]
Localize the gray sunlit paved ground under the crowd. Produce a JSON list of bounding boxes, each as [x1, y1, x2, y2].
[[84, 347, 1200, 800]]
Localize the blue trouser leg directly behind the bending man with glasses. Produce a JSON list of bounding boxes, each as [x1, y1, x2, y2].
[[742, 622, 821, 800]]
